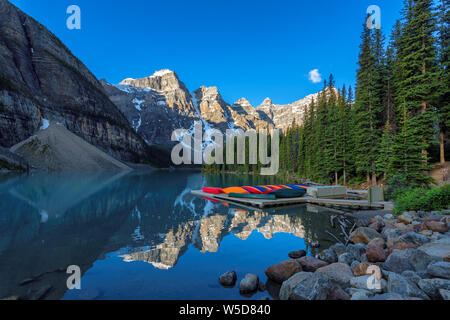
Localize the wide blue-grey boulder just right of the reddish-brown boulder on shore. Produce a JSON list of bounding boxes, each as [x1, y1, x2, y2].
[[383, 249, 435, 273]]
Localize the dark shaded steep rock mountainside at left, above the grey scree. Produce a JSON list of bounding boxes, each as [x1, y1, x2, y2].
[[0, 0, 168, 169]]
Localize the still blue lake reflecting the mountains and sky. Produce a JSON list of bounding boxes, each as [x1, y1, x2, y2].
[[0, 171, 342, 300]]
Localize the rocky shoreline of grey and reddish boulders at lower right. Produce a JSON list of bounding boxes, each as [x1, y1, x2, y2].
[[219, 210, 450, 300]]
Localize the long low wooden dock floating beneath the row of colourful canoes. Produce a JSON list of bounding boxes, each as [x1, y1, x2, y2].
[[191, 190, 392, 210]]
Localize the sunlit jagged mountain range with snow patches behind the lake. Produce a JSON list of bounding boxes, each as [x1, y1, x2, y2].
[[101, 69, 337, 145]]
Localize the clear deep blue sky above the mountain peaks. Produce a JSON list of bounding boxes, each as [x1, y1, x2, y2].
[[11, 0, 402, 106]]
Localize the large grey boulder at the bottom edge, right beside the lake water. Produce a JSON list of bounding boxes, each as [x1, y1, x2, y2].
[[280, 272, 333, 300]]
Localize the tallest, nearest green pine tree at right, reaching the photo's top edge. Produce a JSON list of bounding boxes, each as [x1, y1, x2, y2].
[[393, 0, 439, 183]]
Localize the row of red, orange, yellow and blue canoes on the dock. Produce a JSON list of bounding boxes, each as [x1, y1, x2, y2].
[[202, 184, 308, 200]]
